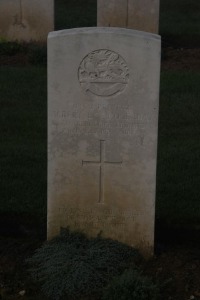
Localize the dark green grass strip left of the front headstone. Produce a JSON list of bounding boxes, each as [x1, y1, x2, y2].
[[0, 66, 47, 214]]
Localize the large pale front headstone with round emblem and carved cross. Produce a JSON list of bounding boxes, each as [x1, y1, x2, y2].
[[48, 28, 160, 255]]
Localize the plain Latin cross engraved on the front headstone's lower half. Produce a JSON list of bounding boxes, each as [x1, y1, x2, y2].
[[82, 140, 122, 203]]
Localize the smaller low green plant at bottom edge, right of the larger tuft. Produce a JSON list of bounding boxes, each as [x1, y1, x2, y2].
[[102, 269, 159, 300]]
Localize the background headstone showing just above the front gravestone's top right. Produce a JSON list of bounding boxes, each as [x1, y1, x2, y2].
[[97, 0, 160, 33]]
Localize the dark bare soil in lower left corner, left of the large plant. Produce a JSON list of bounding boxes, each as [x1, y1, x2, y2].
[[0, 236, 44, 300]]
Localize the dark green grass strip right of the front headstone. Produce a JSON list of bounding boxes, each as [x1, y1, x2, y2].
[[157, 72, 200, 225]]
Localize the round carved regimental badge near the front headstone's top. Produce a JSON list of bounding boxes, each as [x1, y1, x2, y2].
[[78, 49, 129, 96]]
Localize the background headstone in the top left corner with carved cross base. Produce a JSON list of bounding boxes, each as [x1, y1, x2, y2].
[[0, 0, 54, 42]]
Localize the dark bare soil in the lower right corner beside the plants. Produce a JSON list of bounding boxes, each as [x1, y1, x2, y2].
[[145, 246, 200, 300]]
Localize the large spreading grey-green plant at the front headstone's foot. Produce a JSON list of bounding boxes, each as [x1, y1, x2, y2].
[[28, 228, 141, 300]]
